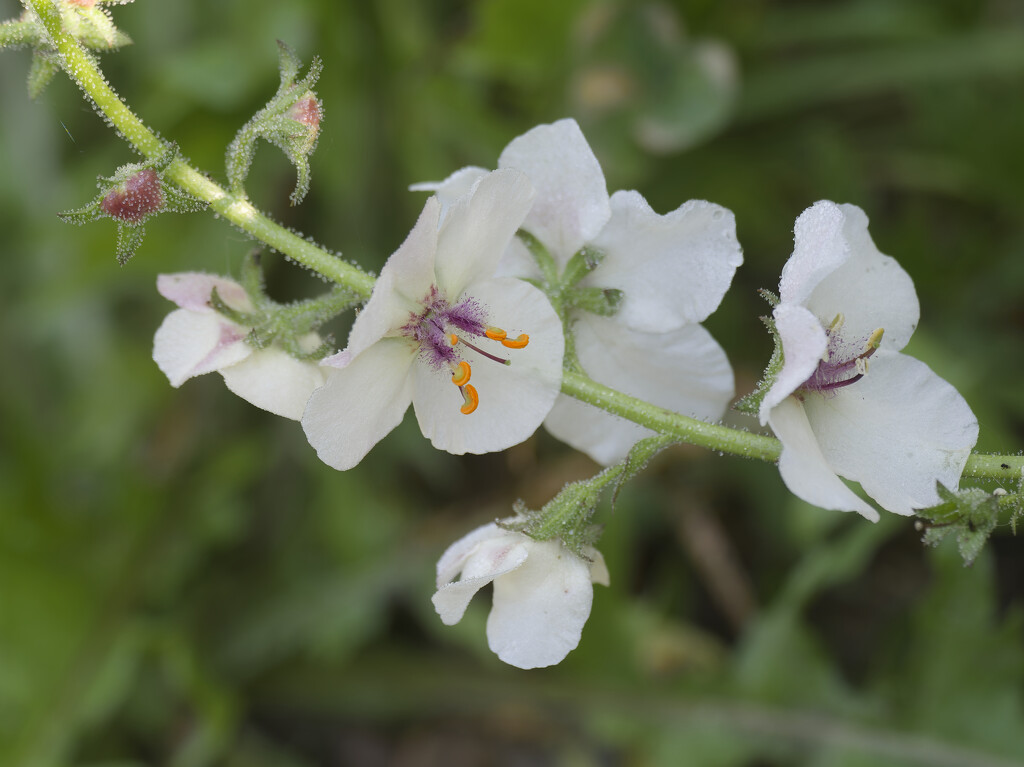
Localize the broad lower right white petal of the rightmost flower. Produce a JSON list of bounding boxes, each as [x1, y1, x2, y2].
[[804, 349, 978, 514]]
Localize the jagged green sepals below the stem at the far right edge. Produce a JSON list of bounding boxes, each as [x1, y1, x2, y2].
[[915, 482, 999, 565]]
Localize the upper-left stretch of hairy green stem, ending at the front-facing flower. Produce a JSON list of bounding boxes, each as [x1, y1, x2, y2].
[[25, 0, 375, 298]]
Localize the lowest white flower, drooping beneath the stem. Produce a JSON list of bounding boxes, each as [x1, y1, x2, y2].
[[432, 523, 608, 669]]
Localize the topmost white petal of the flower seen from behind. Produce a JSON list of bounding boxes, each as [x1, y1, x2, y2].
[[498, 120, 611, 267]]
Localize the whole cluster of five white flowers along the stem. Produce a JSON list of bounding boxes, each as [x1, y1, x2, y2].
[[154, 119, 978, 669]]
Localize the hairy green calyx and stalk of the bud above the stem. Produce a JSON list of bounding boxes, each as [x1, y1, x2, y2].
[[226, 40, 324, 205]]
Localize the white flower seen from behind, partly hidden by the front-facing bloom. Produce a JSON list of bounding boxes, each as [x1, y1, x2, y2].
[[413, 120, 742, 465]]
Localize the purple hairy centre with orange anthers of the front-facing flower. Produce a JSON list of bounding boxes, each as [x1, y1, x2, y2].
[[401, 286, 529, 416]]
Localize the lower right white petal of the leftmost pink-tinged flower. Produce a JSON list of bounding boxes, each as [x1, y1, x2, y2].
[[220, 346, 324, 421]]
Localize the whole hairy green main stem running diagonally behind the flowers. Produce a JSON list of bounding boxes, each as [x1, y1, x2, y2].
[[24, 0, 1024, 482]]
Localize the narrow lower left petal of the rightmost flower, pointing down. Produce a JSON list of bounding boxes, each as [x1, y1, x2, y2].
[[768, 397, 879, 522]]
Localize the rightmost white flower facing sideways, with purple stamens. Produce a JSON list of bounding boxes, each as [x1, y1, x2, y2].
[[760, 202, 978, 520]]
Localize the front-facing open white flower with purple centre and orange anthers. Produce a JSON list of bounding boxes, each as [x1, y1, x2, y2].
[[302, 170, 564, 469]]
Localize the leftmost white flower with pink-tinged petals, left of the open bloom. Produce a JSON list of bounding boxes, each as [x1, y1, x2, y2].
[[153, 271, 324, 421]]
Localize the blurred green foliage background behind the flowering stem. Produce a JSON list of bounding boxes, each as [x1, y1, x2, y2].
[[0, 0, 1024, 767]]
